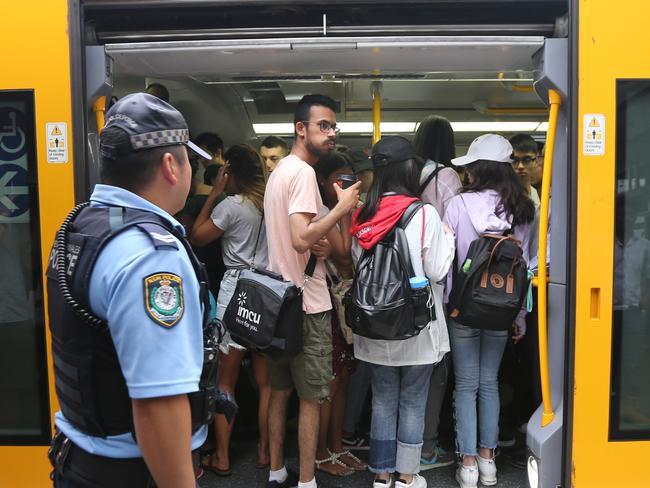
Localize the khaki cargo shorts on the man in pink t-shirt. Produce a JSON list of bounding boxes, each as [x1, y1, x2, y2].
[[269, 311, 332, 401]]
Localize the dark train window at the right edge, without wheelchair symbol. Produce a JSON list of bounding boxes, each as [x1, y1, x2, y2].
[[610, 80, 650, 440]]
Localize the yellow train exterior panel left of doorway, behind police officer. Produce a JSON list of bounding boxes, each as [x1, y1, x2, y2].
[[0, 0, 75, 488]]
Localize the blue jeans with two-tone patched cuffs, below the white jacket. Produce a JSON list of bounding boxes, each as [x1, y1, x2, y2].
[[369, 364, 433, 474]]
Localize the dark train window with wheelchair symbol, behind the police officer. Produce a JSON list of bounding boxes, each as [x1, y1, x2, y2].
[[0, 91, 50, 445]]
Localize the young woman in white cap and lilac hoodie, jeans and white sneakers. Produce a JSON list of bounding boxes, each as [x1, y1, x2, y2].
[[444, 134, 535, 488]]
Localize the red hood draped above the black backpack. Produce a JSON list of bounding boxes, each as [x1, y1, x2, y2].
[[350, 195, 419, 250]]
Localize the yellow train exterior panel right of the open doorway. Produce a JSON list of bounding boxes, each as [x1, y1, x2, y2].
[[571, 0, 650, 488]]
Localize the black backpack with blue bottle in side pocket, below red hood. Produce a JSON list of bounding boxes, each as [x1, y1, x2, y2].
[[343, 201, 435, 341]]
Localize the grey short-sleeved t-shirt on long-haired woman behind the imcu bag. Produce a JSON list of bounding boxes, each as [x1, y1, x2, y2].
[[210, 195, 269, 268]]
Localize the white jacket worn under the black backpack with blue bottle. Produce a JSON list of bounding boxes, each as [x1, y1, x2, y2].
[[352, 205, 455, 366]]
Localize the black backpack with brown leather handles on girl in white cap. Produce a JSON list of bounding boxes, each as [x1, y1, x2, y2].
[[449, 231, 530, 330]]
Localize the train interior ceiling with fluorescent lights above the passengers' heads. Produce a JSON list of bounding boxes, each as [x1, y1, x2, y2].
[[114, 43, 547, 151]]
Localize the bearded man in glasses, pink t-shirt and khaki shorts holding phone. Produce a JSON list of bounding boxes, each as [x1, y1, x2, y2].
[[264, 95, 360, 488]]
